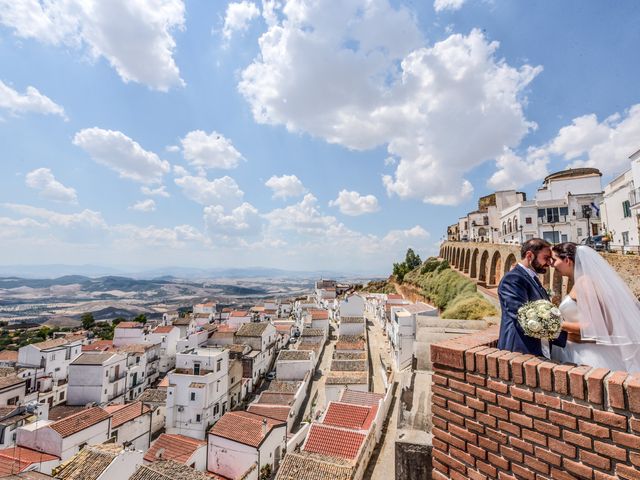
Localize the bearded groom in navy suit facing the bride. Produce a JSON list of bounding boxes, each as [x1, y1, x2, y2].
[[498, 238, 567, 358]]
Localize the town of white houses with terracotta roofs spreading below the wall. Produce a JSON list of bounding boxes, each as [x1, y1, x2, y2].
[[0, 280, 444, 480]]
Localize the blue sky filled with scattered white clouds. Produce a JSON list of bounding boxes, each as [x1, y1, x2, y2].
[[0, 0, 640, 273]]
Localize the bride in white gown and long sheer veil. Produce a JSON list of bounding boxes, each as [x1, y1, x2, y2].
[[551, 242, 640, 372]]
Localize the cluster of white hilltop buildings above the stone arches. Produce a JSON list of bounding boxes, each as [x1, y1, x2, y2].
[[447, 150, 640, 253]]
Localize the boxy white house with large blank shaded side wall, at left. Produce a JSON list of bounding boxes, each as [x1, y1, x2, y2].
[[67, 352, 127, 405]]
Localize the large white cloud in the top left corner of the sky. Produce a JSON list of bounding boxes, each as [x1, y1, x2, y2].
[[0, 0, 185, 91]]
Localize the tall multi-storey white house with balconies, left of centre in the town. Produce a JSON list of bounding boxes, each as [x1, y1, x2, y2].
[[166, 348, 229, 439]]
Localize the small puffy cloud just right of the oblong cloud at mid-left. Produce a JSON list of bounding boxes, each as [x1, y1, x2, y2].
[[175, 176, 244, 207]]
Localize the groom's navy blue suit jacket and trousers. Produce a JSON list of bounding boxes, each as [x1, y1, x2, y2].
[[498, 265, 567, 356]]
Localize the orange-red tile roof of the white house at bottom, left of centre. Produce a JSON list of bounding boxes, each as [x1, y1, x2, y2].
[[209, 411, 282, 447]]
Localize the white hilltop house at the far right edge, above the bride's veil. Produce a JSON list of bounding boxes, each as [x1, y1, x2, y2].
[[600, 169, 640, 252]]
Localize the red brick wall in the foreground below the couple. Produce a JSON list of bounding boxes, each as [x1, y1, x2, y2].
[[431, 328, 640, 480]]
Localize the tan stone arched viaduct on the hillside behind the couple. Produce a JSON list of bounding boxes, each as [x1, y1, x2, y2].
[[440, 242, 569, 298]]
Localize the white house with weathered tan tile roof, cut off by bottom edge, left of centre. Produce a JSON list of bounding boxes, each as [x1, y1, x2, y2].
[[52, 443, 142, 480]]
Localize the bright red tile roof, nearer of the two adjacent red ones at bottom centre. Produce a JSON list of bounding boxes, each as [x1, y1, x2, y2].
[[303, 423, 366, 459]]
